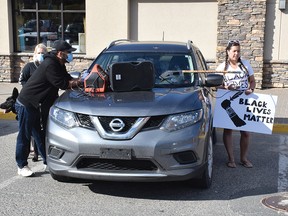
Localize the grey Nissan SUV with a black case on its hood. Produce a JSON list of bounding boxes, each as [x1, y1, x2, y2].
[[46, 40, 222, 188]]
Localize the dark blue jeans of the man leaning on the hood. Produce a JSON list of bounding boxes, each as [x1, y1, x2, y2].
[[15, 101, 46, 168]]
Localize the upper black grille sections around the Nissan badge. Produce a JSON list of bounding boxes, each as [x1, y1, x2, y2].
[[77, 114, 166, 133]]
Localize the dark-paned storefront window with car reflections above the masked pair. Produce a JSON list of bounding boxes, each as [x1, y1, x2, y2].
[[13, 0, 86, 53]]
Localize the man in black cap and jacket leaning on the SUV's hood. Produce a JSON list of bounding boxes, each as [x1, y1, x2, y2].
[[15, 40, 81, 177]]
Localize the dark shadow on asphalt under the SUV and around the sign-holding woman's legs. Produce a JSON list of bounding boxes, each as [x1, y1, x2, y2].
[[71, 132, 281, 201]]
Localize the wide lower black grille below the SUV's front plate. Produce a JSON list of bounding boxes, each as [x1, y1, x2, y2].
[[76, 158, 158, 171]]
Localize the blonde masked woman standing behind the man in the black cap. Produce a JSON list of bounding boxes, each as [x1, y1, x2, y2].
[[19, 43, 47, 162]]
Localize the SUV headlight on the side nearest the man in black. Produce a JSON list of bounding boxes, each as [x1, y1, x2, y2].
[[50, 106, 78, 128]]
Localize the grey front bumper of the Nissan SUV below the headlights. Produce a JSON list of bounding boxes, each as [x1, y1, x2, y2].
[[46, 117, 207, 182]]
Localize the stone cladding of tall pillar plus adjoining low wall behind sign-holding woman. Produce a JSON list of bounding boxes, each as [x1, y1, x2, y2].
[[214, 0, 288, 88]]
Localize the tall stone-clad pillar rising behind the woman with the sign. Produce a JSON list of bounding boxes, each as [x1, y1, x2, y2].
[[216, 0, 266, 88]]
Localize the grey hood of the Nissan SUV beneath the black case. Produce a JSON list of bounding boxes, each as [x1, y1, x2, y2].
[[54, 87, 203, 117]]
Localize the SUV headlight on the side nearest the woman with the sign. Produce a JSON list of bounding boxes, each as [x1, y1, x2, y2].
[[160, 109, 203, 132]]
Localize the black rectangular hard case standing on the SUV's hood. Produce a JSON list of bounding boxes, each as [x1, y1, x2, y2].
[[110, 61, 155, 92]]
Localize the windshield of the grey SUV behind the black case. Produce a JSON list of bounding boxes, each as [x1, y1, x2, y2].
[[88, 52, 194, 87]]
